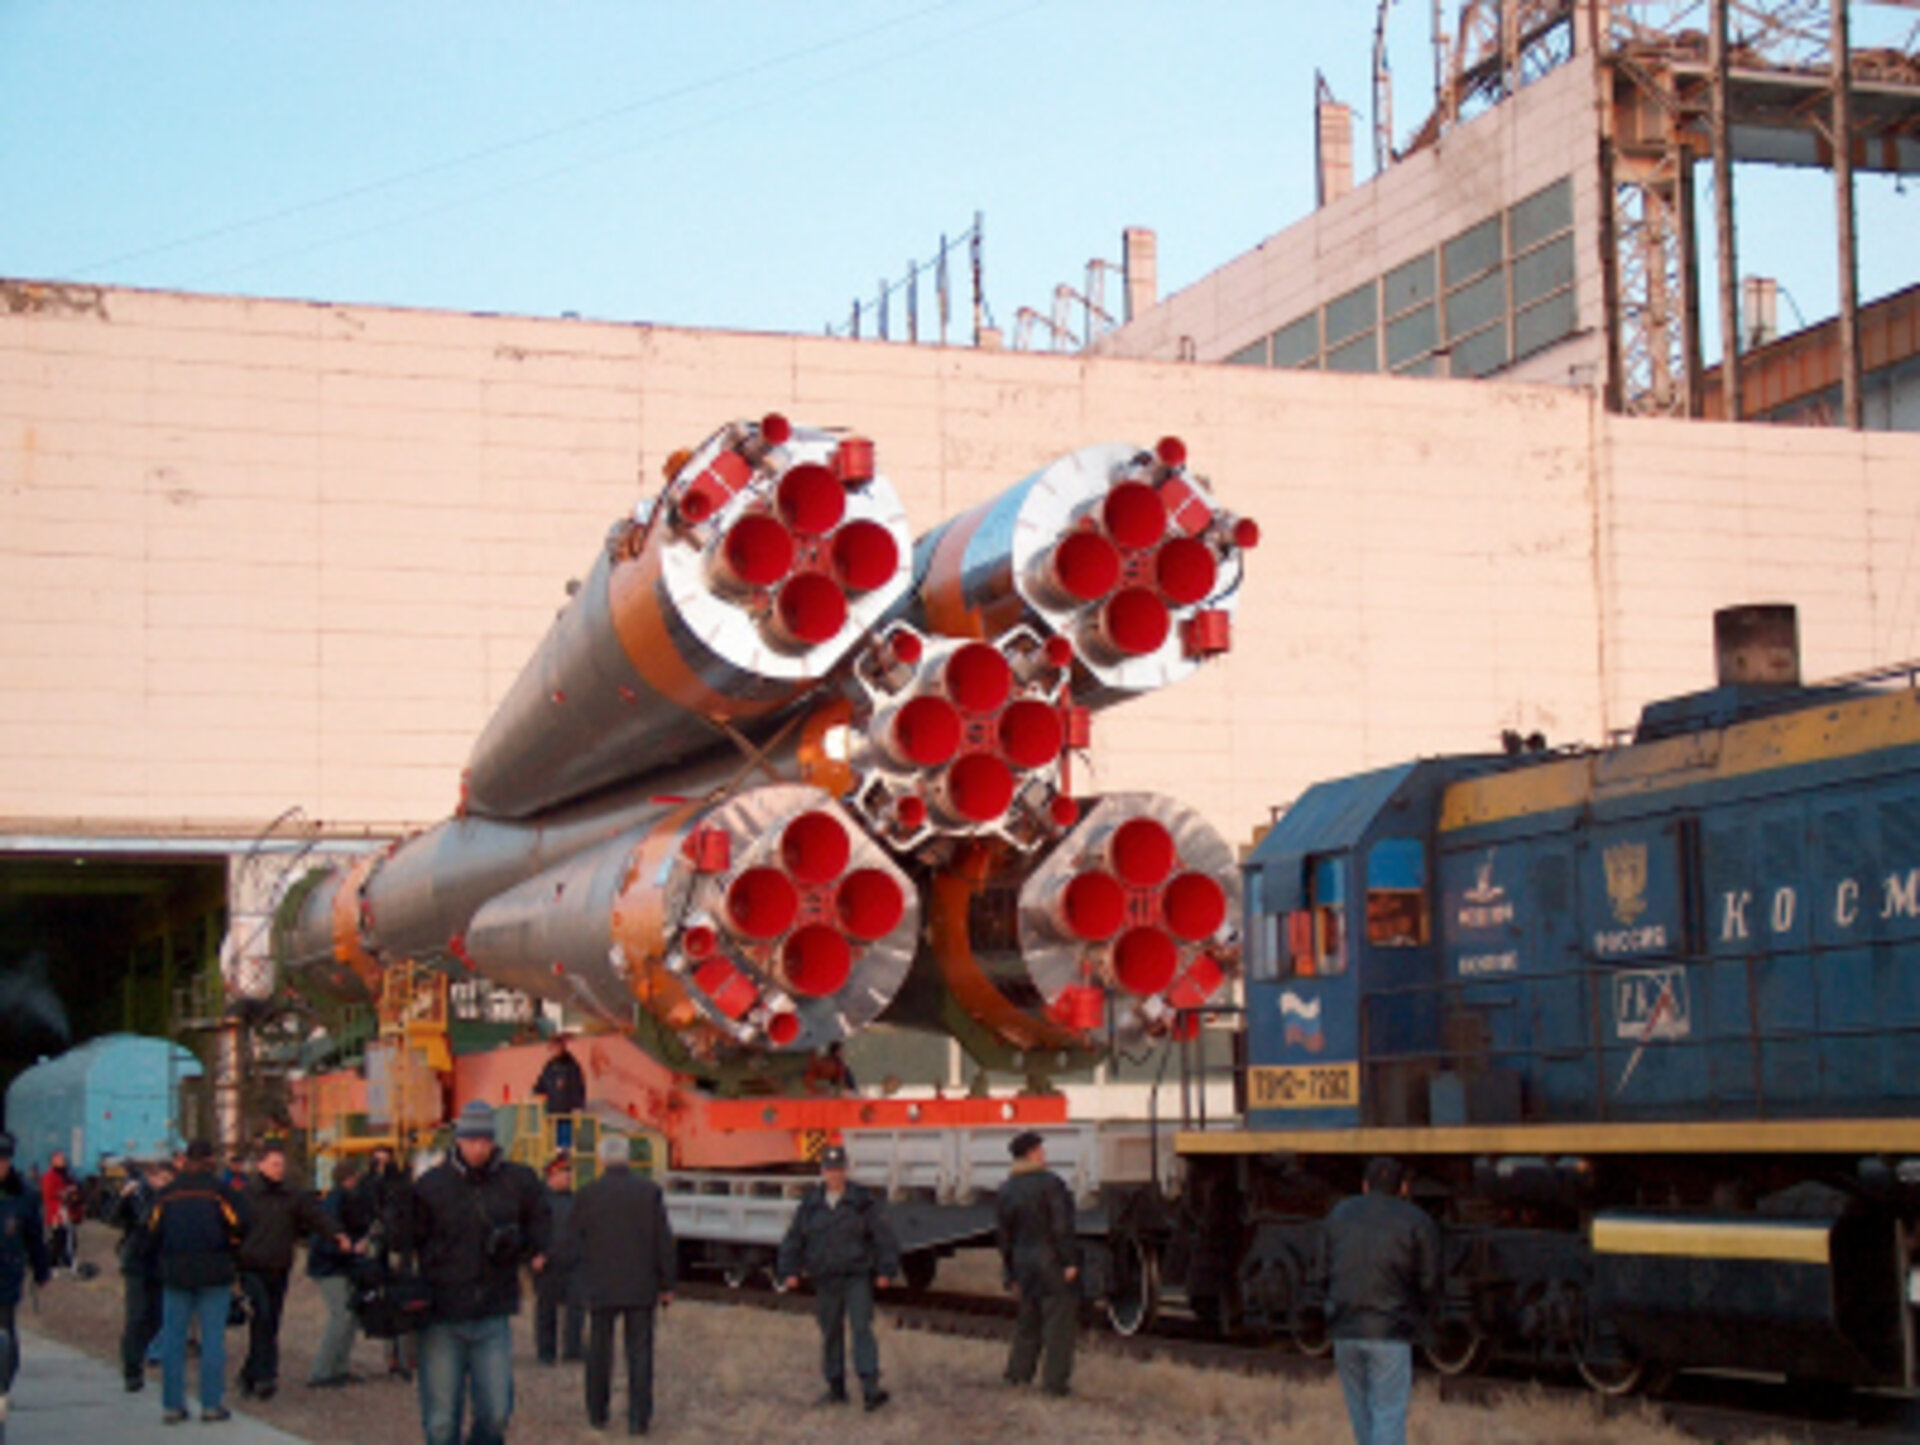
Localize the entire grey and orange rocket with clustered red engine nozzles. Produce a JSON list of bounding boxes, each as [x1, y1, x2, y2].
[[273, 415, 1260, 1078]]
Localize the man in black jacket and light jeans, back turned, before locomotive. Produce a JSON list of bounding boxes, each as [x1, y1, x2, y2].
[[1319, 1157, 1440, 1445]]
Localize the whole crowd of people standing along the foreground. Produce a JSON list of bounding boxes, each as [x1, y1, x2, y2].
[[0, 1048, 1438, 1445]]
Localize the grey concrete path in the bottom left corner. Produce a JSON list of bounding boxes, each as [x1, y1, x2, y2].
[[6, 1328, 301, 1445]]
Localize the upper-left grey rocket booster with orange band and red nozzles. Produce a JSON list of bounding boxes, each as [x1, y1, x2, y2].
[[465, 416, 908, 817]]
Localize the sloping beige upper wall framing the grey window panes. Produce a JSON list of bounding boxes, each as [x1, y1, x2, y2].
[[1092, 52, 1607, 386]]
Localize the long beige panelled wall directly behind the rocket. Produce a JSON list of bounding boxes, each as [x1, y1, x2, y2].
[[0, 284, 1920, 855]]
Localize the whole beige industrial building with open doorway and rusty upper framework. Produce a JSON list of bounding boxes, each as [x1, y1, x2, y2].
[[0, 2, 1920, 1113]]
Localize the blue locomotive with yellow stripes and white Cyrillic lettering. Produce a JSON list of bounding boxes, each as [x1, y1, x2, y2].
[[1159, 606, 1920, 1391]]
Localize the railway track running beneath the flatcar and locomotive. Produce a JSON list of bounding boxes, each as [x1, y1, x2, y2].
[[680, 1280, 1920, 1445]]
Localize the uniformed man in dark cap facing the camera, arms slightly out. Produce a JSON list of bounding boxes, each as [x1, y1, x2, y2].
[[778, 1144, 900, 1410]]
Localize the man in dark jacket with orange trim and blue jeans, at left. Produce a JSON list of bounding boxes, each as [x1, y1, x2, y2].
[[146, 1140, 246, 1426]]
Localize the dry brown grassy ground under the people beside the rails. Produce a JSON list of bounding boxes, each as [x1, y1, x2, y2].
[[23, 1224, 1758, 1445]]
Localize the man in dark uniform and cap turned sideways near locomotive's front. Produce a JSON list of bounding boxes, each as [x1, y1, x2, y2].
[[995, 1130, 1079, 1395]]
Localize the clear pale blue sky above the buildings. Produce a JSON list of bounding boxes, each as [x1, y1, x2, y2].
[[0, 0, 1920, 353]]
